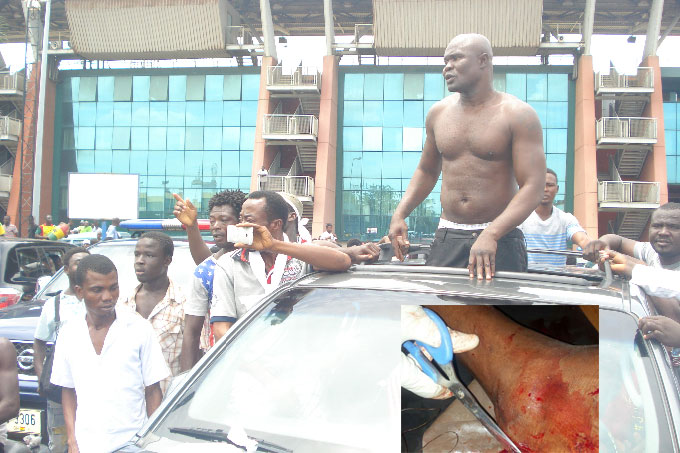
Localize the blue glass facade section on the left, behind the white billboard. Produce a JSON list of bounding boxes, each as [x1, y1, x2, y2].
[[52, 68, 260, 218]]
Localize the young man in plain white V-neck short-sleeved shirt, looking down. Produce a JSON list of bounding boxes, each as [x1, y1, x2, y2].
[[51, 255, 170, 453]]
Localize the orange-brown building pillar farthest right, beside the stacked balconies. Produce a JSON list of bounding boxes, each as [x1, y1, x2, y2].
[[640, 56, 668, 204]]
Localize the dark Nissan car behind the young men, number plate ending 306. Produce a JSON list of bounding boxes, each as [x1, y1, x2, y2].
[[0, 239, 202, 442]]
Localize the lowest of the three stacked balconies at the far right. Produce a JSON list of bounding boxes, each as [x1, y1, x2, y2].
[[597, 181, 660, 211]]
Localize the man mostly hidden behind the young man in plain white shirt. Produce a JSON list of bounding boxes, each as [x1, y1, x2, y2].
[[33, 247, 90, 453]]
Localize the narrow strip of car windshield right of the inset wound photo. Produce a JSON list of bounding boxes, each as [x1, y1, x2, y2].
[[600, 310, 673, 452]]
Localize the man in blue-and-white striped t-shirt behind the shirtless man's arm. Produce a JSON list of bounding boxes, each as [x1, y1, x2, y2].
[[519, 168, 590, 268]]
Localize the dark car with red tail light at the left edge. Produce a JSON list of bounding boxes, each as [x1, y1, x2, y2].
[[0, 238, 73, 308]]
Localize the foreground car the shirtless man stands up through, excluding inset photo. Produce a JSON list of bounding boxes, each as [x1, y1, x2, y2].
[[114, 265, 680, 453]]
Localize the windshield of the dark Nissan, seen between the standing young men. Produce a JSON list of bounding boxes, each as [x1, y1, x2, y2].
[[36, 241, 196, 300]]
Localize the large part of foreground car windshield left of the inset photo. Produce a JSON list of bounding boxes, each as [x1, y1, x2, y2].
[[137, 289, 400, 452]]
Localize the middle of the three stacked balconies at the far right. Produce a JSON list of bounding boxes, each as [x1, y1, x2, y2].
[[596, 117, 656, 145]]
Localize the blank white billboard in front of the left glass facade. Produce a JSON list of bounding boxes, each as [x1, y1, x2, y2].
[[68, 173, 139, 220]]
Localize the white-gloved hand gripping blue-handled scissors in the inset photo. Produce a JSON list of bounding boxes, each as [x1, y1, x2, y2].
[[400, 305, 479, 399]]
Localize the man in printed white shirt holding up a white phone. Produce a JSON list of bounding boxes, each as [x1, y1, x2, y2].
[[210, 191, 351, 341]]
